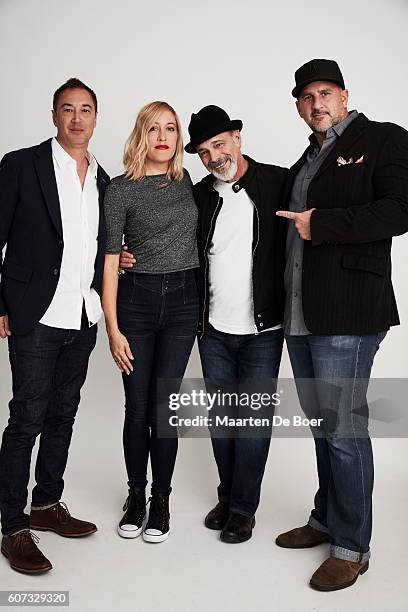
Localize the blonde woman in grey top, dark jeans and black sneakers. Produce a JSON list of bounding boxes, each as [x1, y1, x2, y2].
[[103, 102, 198, 542]]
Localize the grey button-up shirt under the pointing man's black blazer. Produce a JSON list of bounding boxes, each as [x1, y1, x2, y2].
[[284, 111, 358, 336]]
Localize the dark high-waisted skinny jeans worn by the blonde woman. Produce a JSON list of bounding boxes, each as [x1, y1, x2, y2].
[[117, 269, 198, 495]]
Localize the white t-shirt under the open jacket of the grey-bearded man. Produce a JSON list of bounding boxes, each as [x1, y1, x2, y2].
[[208, 180, 281, 335]]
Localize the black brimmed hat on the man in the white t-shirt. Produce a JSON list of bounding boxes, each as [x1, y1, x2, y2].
[[184, 104, 242, 153]]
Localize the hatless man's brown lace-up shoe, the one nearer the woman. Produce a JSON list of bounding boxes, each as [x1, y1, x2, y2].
[[30, 502, 97, 538]]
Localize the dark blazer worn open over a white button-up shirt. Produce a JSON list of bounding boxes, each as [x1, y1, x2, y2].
[[0, 139, 109, 334]]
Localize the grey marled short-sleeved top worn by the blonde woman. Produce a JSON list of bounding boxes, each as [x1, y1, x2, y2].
[[104, 170, 198, 274]]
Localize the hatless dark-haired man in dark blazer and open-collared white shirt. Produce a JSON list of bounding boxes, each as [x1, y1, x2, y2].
[[0, 79, 109, 574]]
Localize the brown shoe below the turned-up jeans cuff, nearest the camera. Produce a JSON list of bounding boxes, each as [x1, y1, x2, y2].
[[310, 557, 369, 591]]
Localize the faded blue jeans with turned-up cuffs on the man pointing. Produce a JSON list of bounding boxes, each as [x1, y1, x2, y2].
[[285, 332, 386, 561]]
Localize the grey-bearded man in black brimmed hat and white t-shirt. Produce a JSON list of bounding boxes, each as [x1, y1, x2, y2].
[[185, 106, 287, 543]]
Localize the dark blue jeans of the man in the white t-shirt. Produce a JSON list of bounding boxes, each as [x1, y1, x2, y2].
[[199, 325, 283, 516]]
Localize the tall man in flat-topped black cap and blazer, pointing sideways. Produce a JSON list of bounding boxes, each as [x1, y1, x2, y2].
[[276, 60, 408, 591]]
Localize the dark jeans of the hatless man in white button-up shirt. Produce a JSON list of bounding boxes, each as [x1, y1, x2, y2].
[[0, 321, 96, 534]]
